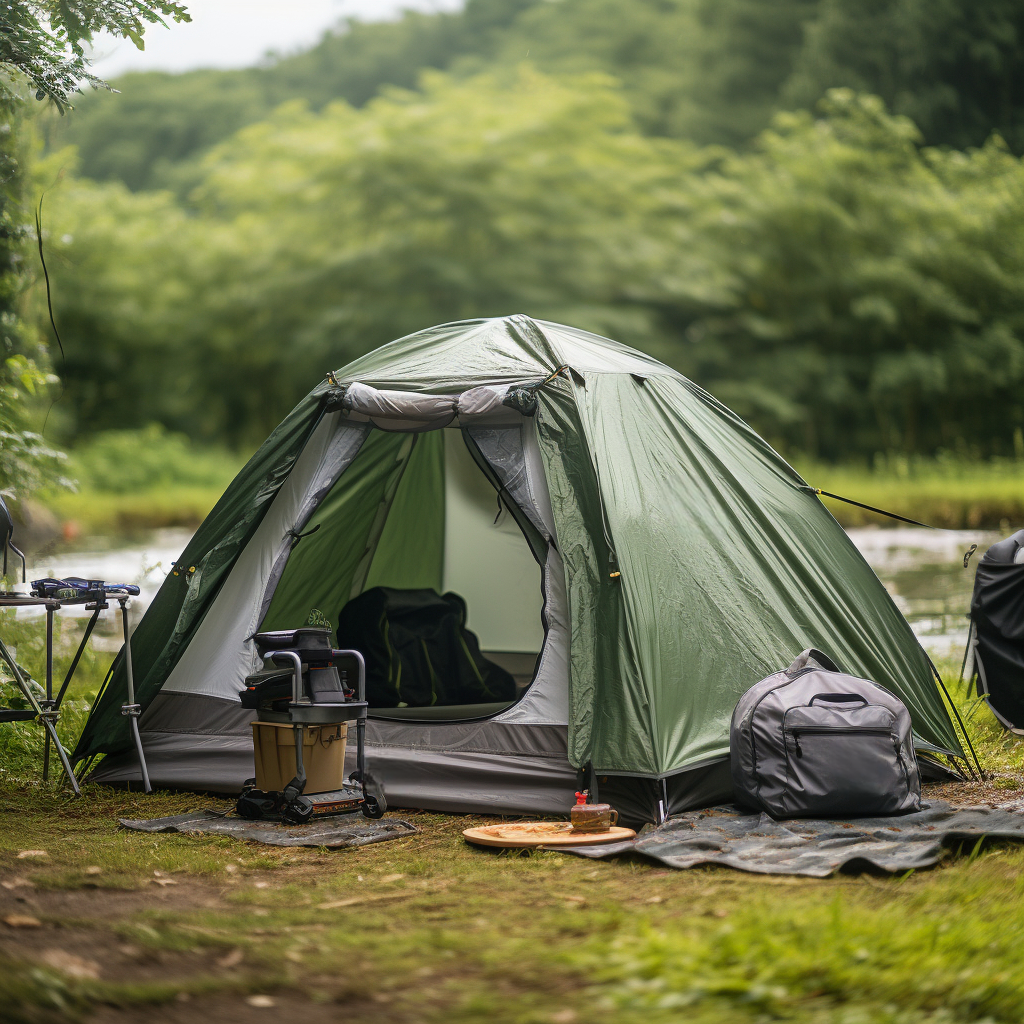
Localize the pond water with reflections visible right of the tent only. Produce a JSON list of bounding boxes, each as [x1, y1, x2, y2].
[[849, 528, 1001, 657]]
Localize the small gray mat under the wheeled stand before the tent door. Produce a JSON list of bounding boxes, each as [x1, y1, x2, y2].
[[118, 811, 420, 847]]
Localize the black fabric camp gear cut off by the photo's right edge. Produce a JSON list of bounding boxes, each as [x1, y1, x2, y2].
[[966, 529, 1024, 735]]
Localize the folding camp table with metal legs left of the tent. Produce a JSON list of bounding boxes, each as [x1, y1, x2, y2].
[[0, 581, 153, 797]]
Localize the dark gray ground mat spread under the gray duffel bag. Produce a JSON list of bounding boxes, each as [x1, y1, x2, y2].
[[558, 801, 1024, 879]]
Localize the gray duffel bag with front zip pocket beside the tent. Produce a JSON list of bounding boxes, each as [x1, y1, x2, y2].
[[730, 650, 921, 818]]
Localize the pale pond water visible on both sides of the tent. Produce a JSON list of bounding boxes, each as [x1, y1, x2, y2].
[[9, 528, 999, 657]]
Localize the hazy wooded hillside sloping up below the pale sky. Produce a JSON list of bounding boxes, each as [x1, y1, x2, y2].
[[50, 0, 818, 193]]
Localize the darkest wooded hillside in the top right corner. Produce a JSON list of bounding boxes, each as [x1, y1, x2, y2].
[[782, 0, 1024, 153]]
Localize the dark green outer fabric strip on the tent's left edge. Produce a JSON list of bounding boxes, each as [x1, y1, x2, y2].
[[73, 384, 336, 761]]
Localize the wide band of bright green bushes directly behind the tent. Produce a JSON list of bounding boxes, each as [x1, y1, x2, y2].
[[44, 75, 1024, 461]]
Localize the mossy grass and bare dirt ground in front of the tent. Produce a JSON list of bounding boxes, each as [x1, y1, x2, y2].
[[0, 638, 1024, 1024]]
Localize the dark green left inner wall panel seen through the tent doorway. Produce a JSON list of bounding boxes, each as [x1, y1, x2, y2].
[[260, 430, 419, 630]]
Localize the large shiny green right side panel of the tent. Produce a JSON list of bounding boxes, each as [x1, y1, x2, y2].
[[577, 374, 959, 774]]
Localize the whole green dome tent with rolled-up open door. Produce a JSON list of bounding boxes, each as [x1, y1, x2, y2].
[[76, 315, 963, 818]]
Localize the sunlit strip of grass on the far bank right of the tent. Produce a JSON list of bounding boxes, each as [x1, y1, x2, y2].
[[797, 459, 1024, 532]]
